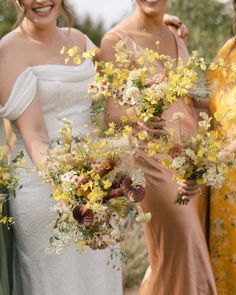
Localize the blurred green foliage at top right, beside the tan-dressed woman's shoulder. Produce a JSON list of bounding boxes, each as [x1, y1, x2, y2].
[[168, 0, 233, 61]]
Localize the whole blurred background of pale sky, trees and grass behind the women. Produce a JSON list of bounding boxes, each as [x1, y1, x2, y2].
[[0, 0, 233, 295]]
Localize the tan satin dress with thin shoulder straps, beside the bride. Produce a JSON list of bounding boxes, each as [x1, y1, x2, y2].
[[106, 30, 216, 295]]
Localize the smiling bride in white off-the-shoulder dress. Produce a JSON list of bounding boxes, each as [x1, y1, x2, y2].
[[0, 0, 122, 295]]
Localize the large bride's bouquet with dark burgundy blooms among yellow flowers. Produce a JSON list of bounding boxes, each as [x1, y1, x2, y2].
[[40, 119, 150, 260]]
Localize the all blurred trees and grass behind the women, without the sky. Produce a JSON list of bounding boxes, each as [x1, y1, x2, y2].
[[0, 0, 233, 294]]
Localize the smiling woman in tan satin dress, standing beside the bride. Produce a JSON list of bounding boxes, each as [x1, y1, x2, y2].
[[101, 0, 216, 295]]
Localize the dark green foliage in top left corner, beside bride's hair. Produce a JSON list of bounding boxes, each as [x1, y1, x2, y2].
[[0, 0, 17, 38]]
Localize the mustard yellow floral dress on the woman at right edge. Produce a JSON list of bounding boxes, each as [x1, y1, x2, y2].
[[208, 39, 236, 295]]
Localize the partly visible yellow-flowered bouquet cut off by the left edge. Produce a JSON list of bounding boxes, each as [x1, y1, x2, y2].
[[0, 145, 25, 226]]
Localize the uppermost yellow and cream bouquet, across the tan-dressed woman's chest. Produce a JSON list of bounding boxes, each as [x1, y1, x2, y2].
[[89, 40, 206, 121]]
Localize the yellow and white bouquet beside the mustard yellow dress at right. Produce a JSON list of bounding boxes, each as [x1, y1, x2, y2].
[[162, 113, 234, 205]]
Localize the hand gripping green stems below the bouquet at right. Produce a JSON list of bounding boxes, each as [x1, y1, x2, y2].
[[178, 180, 203, 204]]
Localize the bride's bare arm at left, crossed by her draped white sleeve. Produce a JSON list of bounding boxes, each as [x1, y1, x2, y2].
[[0, 43, 48, 166]]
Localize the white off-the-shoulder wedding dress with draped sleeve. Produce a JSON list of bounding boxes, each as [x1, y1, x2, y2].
[[0, 39, 122, 295]]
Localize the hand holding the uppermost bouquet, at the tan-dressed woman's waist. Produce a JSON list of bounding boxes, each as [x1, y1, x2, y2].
[[138, 117, 166, 136]]
